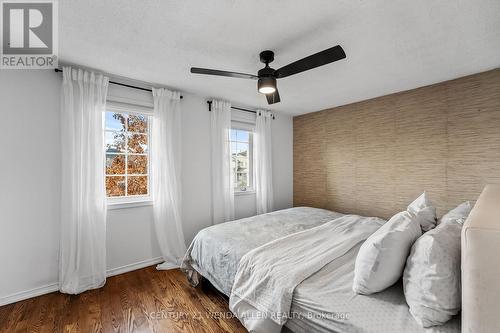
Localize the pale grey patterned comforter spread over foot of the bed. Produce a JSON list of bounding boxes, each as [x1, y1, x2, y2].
[[181, 207, 343, 296]]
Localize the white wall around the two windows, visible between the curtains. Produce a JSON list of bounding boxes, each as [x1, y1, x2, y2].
[[0, 70, 293, 304]]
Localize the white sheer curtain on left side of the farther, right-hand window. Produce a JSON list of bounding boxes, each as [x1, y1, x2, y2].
[[210, 100, 234, 224]]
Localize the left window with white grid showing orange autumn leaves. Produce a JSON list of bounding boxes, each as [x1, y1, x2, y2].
[[104, 110, 151, 201]]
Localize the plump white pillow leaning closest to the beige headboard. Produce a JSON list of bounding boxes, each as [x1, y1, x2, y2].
[[403, 202, 472, 327]]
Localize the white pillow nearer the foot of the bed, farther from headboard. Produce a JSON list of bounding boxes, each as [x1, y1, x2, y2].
[[352, 192, 436, 295]]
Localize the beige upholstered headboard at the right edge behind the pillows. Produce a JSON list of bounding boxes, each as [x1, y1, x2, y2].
[[462, 185, 500, 333]]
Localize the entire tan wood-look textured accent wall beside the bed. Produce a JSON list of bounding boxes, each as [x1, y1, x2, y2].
[[293, 69, 500, 218]]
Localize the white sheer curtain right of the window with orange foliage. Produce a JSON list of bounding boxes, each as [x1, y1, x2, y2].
[[151, 89, 186, 269]]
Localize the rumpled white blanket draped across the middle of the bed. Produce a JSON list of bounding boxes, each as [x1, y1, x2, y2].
[[229, 215, 385, 333]]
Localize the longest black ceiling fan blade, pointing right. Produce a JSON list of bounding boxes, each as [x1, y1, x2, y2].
[[276, 45, 346, 78]]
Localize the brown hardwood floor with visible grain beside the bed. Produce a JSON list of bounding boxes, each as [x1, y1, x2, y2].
[[0, 267, 246, 333]]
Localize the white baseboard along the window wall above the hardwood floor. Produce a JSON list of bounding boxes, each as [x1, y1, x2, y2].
[[0, 257, 168, 306]]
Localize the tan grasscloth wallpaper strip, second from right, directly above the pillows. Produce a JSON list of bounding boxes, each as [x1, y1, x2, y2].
[[394, 85, 447, 216]]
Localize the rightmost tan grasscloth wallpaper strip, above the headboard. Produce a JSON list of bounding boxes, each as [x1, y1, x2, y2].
[[448, 70, 500, 202]]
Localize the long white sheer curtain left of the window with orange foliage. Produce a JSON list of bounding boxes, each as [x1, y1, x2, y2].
[[59, 67, 108, 294]]
